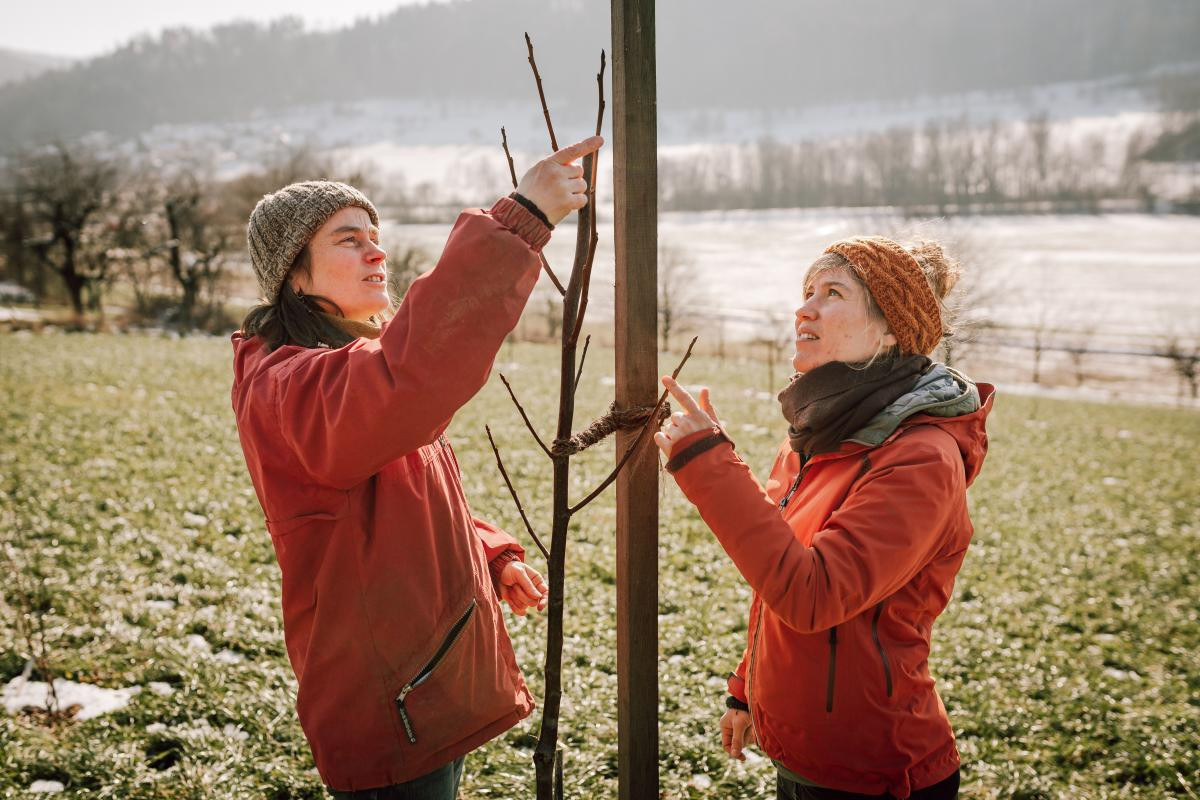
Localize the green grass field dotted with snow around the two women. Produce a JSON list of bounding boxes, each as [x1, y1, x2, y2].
[[0, 335, 1200, 799]]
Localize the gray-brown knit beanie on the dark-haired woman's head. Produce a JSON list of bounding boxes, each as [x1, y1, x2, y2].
[[246, 181, 379, 302]]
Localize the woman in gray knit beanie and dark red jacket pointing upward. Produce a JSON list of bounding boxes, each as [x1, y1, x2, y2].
[[232, 137, 602, 800]]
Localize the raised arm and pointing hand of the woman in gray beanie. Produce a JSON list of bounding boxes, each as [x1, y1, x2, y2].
[[274, 137, 602, 488]]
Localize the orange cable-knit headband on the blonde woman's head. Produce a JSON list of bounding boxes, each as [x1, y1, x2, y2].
[[826, 236, 942, 355]]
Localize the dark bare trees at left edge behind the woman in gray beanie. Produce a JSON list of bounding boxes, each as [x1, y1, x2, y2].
[[0, 143, 425, 331]]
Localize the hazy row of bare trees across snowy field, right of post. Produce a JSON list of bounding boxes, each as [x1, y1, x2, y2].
[[660, 115, 1195, 216]]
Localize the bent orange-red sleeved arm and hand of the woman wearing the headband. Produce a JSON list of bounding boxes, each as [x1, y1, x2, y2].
[[656, 380, 966, 633]]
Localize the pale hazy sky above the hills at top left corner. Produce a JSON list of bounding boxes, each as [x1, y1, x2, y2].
[[0, 0, 444, 58]]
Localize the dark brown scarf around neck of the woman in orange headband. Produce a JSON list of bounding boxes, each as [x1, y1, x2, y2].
[[779, 355, 931, 458]]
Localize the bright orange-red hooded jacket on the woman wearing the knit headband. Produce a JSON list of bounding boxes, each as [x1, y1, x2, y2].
[[676, 384, 992, 798]]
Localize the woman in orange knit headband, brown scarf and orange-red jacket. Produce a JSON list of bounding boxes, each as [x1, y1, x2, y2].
[[655, 236, 992, 800]]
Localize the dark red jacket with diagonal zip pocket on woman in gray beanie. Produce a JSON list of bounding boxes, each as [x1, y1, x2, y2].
[[233, 198, 548, 790]]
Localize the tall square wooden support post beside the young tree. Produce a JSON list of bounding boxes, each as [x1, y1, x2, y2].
[[612, 0, 659, 800]]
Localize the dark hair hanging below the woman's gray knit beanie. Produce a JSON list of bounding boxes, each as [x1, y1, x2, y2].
[[241, 245, 354, 353]]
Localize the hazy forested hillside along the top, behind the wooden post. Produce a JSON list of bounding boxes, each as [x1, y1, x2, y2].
[[0, 0, 1200, 149]]
